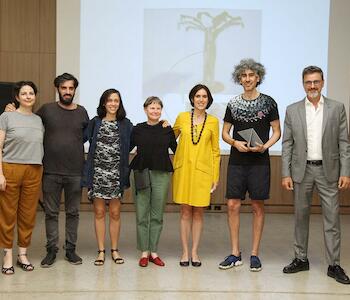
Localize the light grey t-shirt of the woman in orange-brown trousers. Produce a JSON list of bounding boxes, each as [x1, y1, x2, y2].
[[0, 111, 44, 165]]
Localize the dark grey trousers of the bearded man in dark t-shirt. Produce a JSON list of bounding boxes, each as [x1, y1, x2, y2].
[[43, 174, 82, 250]]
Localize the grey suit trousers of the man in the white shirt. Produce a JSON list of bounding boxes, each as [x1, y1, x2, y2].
[[294, 165, 340, 265]]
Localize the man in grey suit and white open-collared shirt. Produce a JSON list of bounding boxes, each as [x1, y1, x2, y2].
[[282, 66, 350, 284]]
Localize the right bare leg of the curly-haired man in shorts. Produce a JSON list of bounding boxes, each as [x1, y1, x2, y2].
[[252, 200, 265, 256]]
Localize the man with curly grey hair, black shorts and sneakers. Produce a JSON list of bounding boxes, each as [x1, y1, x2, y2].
[[219, 59, 281, 271]]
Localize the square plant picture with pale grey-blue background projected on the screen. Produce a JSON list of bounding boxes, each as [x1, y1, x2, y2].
[[143, 9, 261, 121]]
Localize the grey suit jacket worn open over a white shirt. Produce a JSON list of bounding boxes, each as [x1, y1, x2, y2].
[[282, 97, 350, 183]]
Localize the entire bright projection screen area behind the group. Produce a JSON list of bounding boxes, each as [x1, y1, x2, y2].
[[79, 0, 330, 151]]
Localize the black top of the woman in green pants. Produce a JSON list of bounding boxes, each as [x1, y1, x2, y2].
[[130, 122, 177, 172]]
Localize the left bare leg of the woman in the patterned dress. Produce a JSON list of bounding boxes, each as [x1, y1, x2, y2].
[[94, 198, 106, 260]]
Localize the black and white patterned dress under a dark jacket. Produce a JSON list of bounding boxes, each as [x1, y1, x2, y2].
[[88, 120, 122, 202]]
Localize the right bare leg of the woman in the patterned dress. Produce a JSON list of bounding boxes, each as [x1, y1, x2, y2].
[[109, 199, 121, 259]]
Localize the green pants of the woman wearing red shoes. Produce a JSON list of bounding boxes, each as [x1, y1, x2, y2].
[[134, 170, 171, 252]]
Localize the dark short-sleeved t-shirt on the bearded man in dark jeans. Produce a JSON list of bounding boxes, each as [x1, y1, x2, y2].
[[37, 102, 89, 176]]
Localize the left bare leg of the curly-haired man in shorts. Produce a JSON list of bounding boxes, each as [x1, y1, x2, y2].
[[227, 199, 241, 256]]
